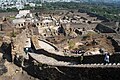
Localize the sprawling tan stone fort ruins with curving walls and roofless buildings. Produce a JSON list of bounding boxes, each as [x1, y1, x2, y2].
[[0, 10, 120, 80]]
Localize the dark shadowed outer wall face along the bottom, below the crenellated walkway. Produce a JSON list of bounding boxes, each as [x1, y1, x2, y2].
[[24, 60, 120, 80]]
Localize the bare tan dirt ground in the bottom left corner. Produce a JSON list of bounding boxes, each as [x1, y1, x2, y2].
[[0, 53, 38, 80]]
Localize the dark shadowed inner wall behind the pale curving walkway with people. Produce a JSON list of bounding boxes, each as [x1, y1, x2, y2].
[[36, 49, 120, 64]]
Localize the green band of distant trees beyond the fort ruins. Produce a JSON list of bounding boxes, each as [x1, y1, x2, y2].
[[0, 2, 120, 21]]
